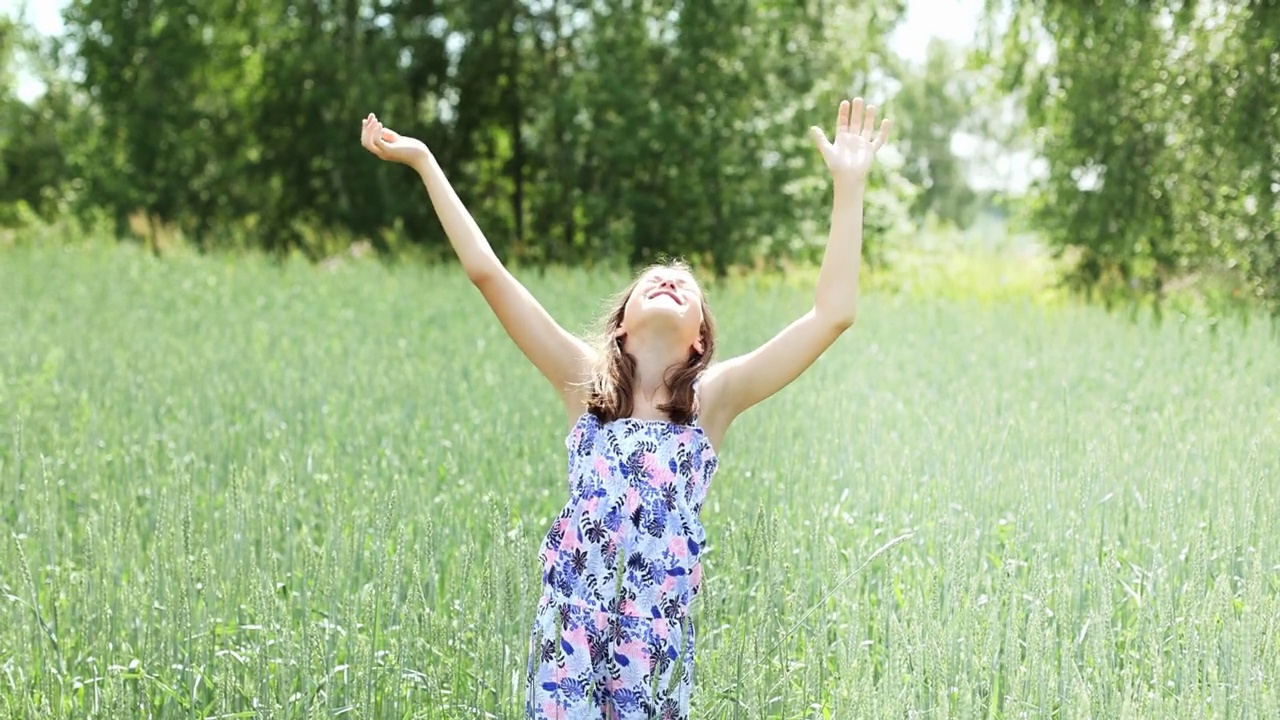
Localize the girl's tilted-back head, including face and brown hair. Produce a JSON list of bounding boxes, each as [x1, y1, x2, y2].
[[588, 261, 716, 424]]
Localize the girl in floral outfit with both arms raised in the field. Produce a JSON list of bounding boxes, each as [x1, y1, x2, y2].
[[361, 97, 890, 720]]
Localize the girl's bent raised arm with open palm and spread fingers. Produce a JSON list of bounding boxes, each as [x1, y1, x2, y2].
[[700, 97, 892, 436]]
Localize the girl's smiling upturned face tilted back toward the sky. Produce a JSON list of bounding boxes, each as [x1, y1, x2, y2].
[[618, 268, 703, 354]]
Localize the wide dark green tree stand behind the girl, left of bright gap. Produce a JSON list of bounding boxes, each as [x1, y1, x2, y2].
[[6, 0, 921, 270]]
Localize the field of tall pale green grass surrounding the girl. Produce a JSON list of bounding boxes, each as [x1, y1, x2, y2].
[[0, 247, 1280, 719]]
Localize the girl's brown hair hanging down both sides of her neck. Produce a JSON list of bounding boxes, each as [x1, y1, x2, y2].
[[586, 260, 716, 425]]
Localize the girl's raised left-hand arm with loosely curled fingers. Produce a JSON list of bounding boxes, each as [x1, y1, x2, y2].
[[361, 114, 594, 416]]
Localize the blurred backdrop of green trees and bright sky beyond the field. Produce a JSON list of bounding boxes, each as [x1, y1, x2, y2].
[[0, 0, 1280, 307]]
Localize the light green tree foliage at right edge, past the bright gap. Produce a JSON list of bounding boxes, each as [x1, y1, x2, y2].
[[987, 0, 1280, 308]]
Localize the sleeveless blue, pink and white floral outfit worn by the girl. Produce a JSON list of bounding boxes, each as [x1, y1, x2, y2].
[[525, 413, 718, 720]]
